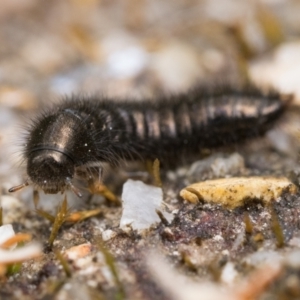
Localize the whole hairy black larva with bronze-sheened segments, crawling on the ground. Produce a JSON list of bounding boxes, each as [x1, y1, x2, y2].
[[10, 88, 285, 195]]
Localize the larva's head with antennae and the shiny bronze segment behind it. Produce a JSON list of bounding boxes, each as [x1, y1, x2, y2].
[[10, 110, 87, 197]]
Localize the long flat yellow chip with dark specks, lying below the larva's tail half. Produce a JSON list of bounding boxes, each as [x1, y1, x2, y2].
[[180, 177, 297, 209]]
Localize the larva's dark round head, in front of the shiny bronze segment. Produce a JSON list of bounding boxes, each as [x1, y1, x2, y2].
[[27, 148, 75, 194]]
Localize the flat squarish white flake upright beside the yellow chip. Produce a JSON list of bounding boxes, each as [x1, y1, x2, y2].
[[120, 179, 171, 231]]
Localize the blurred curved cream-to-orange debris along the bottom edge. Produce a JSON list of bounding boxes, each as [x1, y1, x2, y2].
[[146, 253, 282, 300]]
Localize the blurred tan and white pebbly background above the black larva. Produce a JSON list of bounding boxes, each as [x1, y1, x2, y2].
[[0, 0, 300, 193]]
